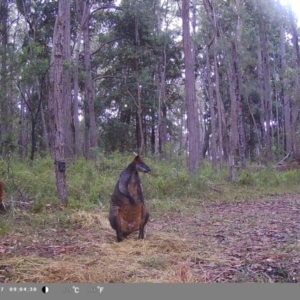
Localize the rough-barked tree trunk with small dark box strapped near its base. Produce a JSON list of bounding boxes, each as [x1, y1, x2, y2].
[[49, 0, 70, 206]]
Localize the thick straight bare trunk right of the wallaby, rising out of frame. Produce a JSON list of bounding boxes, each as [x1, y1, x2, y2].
[[182, 0, 200, 173]]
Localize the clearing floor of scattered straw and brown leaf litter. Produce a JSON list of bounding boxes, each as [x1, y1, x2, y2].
[[0, 195, 300, 283]]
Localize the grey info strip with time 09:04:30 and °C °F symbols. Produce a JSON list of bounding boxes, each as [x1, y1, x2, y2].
[[0, 284, 300, 300]]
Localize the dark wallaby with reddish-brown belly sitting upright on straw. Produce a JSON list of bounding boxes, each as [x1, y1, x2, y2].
[[109, 155, 151, 242]]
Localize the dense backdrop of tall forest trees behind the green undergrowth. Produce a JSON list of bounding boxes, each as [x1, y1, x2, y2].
[[0, 0, 300, 176]]
